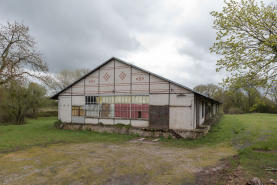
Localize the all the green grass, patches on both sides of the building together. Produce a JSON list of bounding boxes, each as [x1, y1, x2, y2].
[[0, 114, 277, 181]]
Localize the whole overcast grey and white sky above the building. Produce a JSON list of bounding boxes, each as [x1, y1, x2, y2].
[[0, 0, 271, 88]]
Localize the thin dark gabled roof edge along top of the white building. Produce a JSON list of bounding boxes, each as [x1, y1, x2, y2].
[[50, 57, 221, 103]]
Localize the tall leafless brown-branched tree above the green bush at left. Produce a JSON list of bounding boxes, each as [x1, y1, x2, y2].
[[0, 21, 48, 86]]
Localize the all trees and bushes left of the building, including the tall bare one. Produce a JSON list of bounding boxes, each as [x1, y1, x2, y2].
[[0, 21, 88, 125]]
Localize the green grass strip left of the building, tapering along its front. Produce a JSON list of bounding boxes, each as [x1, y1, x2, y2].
[[0, 117, 135, 152]]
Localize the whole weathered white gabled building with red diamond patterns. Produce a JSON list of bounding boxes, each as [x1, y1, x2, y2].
[[51, 57, 220, 130]]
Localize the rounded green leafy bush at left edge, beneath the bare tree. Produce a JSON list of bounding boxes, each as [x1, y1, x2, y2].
[[0, 82, 46, 125]]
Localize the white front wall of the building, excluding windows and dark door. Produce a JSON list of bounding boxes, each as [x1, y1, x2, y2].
[[56, 60, 209, 129]]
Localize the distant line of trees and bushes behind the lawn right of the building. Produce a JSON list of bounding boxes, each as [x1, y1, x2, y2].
[[193, 83, 277, 114]]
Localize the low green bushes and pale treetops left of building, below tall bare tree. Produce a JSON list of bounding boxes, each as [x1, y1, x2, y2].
[[0, 68, 89, 125]]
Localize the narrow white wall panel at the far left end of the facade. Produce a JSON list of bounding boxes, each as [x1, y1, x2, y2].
[[58, 96, 71, 122]]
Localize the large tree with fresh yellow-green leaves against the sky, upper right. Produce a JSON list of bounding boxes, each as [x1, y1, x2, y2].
[[210, 0, 277, 89]]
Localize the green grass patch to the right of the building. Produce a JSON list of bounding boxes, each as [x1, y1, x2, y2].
[[163, 113, 277, 178]]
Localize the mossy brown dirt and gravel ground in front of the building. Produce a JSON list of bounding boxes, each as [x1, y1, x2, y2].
[[0, 142, 236, 184]]
